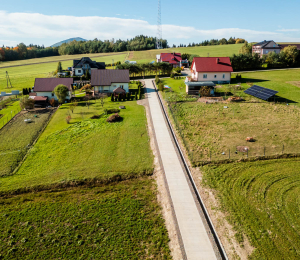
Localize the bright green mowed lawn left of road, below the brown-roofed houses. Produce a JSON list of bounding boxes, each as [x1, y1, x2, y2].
[[0, 98, 153, 192]]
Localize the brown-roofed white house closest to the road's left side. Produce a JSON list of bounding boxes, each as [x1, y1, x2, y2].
[[91, 70, 130, 94]]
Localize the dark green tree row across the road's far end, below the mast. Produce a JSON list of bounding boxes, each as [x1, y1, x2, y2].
[[116, 62, 173, 77]]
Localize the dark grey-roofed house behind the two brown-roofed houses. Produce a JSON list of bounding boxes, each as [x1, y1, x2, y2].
[[72, 57, 105, 77]]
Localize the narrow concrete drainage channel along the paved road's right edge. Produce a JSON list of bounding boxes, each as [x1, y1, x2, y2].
[[152, 80, 228, 260]]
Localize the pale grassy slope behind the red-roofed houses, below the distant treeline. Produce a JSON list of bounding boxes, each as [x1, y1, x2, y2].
[[131, 44, 242, 63]]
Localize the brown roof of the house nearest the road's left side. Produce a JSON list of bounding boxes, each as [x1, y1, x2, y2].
[[91, 70, 130, 86]]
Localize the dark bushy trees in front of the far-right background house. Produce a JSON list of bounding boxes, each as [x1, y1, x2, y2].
[[230, 45, 300, 71]]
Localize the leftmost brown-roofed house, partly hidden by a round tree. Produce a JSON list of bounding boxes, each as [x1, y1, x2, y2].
[[33, 78, 73, 100]]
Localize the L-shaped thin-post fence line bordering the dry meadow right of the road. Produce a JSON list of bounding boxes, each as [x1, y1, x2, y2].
[[167, 102, 300, 166]]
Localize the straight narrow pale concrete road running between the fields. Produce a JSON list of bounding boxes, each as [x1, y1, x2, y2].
[[145, 80, 217, 260]]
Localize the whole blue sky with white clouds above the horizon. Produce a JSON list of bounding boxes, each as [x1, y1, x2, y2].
[[0, 0, 300, 46]]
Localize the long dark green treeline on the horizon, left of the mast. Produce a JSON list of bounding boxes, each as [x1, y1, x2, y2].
[[58, 35, 168, 55]]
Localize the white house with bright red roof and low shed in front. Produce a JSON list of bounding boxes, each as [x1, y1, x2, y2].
[[185, 57, 233, 95]]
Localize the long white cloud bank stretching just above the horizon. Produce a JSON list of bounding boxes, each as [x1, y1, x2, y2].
[[0, 10, 300, 46]]
